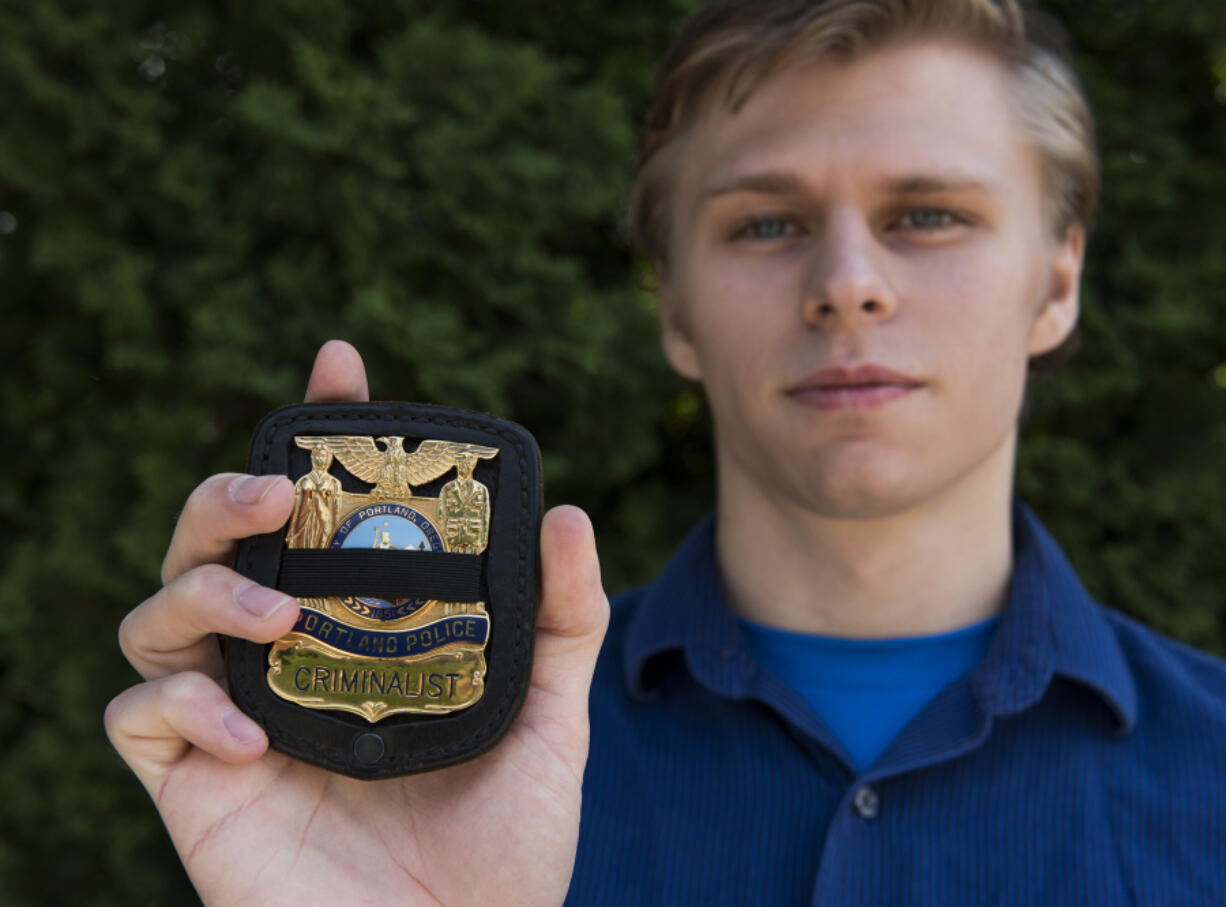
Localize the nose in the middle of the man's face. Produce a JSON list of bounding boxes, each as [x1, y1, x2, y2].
[[803, 208, 897, 328]]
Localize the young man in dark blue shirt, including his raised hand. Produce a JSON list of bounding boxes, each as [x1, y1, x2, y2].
[[108, 0, 1226, 905]]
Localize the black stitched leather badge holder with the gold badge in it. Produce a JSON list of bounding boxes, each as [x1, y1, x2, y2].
[[226, 403, 541, 778]]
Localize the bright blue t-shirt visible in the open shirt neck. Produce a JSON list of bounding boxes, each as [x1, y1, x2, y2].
[[741, 618, 997, 771]]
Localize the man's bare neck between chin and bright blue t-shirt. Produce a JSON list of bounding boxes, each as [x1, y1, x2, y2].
[[716, 436, 1014, 639]]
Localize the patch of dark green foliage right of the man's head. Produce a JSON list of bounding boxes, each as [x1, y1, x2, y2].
[[1018, 0, 1226, 653]]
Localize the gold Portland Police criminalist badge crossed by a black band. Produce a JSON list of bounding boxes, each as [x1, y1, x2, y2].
[[267, 435, 498, 722]]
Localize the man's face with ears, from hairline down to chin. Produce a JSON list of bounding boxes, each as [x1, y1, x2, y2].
[[662, 43, 1081, 518]]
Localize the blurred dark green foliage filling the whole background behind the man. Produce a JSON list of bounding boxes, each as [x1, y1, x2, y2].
[[0, 0, 1226, 903]]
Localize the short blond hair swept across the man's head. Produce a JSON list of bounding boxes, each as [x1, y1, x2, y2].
[[629, 0, 1098, 268]]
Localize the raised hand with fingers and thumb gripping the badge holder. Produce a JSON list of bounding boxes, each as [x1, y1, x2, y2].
[[107, 341, 608, 906]]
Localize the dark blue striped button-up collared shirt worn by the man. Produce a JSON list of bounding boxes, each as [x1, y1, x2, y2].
[[566, 505, 1226, 907]]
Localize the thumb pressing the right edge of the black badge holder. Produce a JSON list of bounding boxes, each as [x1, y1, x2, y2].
[[530, 506, 609, 717]]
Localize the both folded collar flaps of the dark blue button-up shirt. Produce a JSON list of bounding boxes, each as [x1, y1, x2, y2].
[[624, 503, 1137, 733]]
